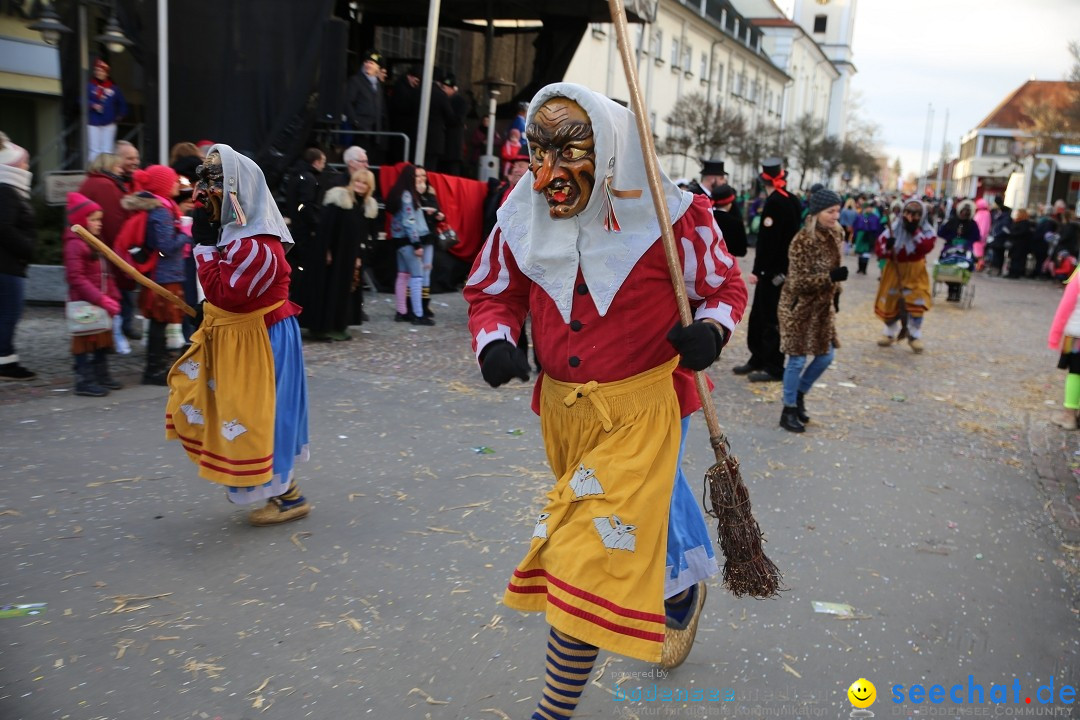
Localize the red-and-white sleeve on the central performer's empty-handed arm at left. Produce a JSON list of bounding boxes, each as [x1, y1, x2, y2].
[[464, 228, 532, 357]]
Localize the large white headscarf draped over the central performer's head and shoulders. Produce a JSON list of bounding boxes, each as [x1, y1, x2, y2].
[[498, 83, 693, 323]]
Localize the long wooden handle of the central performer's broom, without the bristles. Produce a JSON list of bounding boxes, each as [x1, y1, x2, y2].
[[608, 0, 727, 459]]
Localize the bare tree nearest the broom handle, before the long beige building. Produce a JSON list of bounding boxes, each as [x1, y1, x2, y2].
[[658, 93, 746, 161]]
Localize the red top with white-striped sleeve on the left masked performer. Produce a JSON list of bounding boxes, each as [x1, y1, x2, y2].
[[194, 235, 288, 310]]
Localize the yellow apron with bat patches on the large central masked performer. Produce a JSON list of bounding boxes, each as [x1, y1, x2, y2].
[[503, 357, 680, 662]]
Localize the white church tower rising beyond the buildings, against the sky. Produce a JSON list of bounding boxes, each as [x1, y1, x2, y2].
[[792, 0, 858, 140]]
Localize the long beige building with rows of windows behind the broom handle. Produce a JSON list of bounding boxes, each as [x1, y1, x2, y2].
[[565, 0, 789, 186]]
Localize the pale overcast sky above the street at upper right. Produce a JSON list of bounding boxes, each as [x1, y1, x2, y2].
[[779, 0, 1080, 174]]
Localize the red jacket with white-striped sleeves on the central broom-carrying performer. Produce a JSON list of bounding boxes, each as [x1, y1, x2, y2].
[[464, 195, 746, 417]]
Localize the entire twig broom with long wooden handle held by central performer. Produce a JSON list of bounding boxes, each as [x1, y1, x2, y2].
[[608, 0, 782, 598]]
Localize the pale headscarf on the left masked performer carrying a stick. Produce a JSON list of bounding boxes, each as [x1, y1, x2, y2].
[[206, 142, 295, 249]]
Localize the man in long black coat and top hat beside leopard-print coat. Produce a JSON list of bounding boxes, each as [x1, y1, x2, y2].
[[732, 158, 802, 382]]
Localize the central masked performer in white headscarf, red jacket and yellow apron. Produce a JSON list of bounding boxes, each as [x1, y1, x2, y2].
[[465, 83, 746, 720]]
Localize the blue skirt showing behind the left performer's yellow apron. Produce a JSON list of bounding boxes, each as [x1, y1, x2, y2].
[[228, 316, 310, 505]]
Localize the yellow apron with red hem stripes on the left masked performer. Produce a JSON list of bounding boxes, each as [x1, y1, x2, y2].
[[165, 302, 282, 487]]
